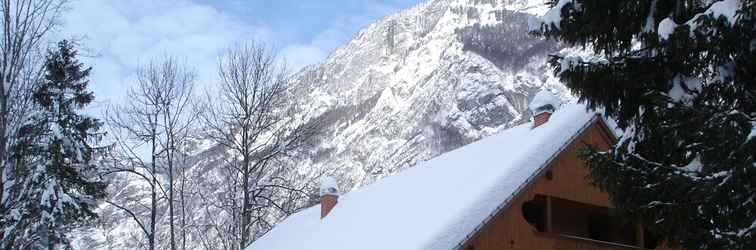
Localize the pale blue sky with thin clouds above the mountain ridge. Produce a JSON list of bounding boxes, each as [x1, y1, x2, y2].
[[56, 0, 420, 106]]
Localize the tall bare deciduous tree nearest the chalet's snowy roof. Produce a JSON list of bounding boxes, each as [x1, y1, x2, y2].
[[201, 44, 315, 249]]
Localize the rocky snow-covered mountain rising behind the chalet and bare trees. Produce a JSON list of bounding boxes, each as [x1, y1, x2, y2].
[[77, 0, 574, 249]]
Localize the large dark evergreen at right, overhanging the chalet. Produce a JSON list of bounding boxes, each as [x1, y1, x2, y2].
[[534, 0, 756, 249]]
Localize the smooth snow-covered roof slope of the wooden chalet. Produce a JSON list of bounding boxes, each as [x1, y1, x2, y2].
[[247, 105, 596, 250]]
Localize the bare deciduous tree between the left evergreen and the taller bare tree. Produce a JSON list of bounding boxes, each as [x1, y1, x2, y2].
[[108, 58, 197, 249]]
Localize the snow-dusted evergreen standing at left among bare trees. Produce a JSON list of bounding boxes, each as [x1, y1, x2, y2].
[[7, 40, 106, 249]]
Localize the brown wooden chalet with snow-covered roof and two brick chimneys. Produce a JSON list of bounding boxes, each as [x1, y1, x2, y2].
[[247, 92, 674, 250]]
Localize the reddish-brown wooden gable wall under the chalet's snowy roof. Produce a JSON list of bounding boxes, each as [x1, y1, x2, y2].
[[462, 121, 673, 250]]
